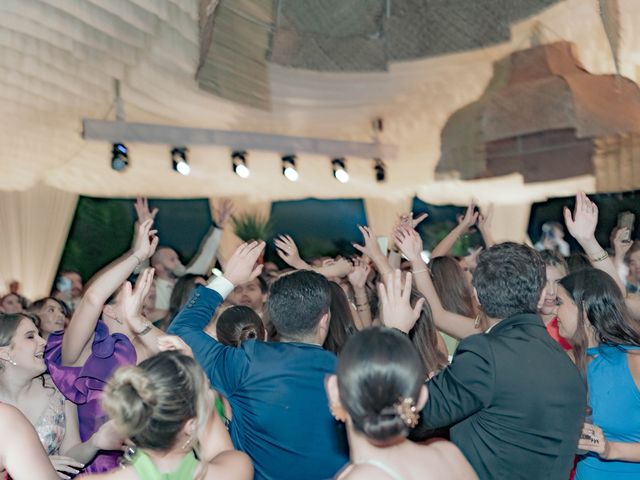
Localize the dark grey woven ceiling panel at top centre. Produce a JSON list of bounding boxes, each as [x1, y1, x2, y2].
[[268, 0, 559, 71]]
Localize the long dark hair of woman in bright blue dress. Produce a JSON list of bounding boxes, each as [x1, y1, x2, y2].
[[560, 268, 640, 372]]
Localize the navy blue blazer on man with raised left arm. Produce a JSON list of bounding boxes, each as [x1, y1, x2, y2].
[[169, 286, 348, 480]]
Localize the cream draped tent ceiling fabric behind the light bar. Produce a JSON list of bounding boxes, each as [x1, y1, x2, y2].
[[0, 0, 640, 202]]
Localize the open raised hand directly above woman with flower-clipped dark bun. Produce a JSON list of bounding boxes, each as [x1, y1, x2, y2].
[[378, 270, 424, 333]]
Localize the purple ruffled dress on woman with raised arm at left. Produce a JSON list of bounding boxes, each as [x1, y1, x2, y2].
[[45, 320, 137, 473]]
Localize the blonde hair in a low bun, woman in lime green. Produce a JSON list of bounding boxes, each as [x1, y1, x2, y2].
[[102, 351, 213, 451]]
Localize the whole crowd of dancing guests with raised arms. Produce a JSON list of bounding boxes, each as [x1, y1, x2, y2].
[[0, 193, 640, 480]]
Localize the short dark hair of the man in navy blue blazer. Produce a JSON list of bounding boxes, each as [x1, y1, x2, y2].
[[267, 270, 331, 340]]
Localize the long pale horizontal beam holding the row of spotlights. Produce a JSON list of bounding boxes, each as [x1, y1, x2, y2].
[[82, 119, 397, 160]]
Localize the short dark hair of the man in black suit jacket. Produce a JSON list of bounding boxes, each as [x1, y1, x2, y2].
[[473, 242, 547, 319]]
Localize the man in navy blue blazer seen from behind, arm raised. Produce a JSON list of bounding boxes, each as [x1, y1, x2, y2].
[[169, 242, 348, 480]]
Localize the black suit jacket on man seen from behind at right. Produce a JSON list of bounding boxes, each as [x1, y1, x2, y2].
[[422, 314, 587, 480]]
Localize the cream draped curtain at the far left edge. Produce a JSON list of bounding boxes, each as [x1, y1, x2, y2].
[[0, 184, 78, 300]]
